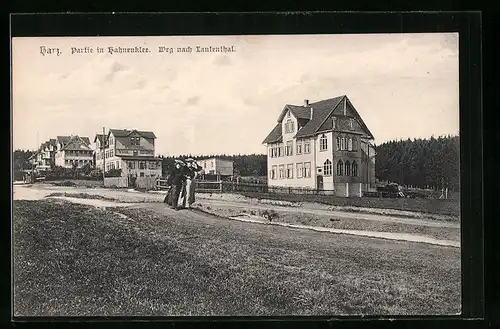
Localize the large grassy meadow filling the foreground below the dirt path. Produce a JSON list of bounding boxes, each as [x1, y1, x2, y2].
[[13, 200, 460, 316]]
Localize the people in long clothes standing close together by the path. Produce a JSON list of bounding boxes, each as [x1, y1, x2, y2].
[[163, 158, 202, 210]]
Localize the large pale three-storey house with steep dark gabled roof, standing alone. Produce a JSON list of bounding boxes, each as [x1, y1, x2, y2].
[[263, 96, 375, 196]]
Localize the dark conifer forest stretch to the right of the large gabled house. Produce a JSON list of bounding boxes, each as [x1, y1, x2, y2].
[[375, 135, 460, 190]]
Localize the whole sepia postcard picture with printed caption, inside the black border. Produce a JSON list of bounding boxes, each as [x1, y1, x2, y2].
[[11, 33, 462, 317]]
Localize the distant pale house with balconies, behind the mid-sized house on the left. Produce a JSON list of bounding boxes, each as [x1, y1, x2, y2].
[[54, 135, 93, 168]]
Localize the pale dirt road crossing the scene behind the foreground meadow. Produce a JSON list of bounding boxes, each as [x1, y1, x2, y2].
[[13, 184, 460, 247]]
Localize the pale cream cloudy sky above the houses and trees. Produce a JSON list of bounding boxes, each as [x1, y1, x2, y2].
[[12, 33, 459, 156]]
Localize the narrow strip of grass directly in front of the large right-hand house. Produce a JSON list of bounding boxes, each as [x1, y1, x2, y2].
[[240, 192, 460, 217]]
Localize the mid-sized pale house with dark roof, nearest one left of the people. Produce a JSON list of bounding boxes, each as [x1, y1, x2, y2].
[[94, 129, 162, 177]]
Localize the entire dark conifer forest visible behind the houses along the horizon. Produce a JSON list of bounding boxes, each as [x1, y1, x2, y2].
[[13, 135, 460, 190]]
